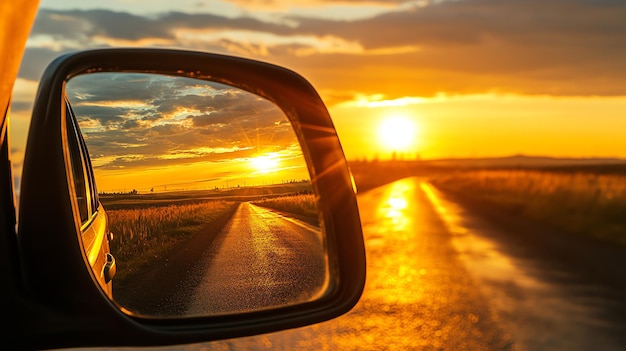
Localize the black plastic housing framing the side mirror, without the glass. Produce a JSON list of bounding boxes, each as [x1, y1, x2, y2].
[[9, 49, 365, 349]]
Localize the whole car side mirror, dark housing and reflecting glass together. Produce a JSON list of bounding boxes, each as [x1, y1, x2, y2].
[[18, 49, 365, 348]]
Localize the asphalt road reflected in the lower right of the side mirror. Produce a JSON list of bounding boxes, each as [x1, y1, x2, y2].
[[186, 202, 326, 315]]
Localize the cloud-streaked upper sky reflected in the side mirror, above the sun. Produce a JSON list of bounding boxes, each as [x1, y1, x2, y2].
[[67, 73, 297, 169]]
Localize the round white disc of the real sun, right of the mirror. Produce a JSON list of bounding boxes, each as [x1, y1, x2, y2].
[[378, 115, 418, 152]]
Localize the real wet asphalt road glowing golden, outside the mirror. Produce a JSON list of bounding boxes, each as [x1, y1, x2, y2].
[[74, 178, 626, 351]]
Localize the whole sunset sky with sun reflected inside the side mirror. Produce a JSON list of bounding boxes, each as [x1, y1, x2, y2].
[[66, 73, 309, 193]]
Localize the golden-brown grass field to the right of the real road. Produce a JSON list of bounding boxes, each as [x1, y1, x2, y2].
[[433, 170, 626, 246]]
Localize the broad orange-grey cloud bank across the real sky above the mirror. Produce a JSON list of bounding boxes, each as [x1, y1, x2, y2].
[[20, 0, 626, 99]]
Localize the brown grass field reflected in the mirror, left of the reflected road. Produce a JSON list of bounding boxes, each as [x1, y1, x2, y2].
[[104, 201, 237, 281]]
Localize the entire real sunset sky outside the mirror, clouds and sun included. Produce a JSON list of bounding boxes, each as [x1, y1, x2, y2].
[[11, 0, 626, 190]]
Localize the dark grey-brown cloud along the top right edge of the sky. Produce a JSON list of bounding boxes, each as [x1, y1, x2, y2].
[[294, 0, 626, 48]]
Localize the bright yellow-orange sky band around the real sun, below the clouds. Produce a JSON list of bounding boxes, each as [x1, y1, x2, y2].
[[330, 94, 626, 159]]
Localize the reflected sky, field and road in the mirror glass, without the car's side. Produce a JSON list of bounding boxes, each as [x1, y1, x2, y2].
[[66, 73, 329, 317]]
